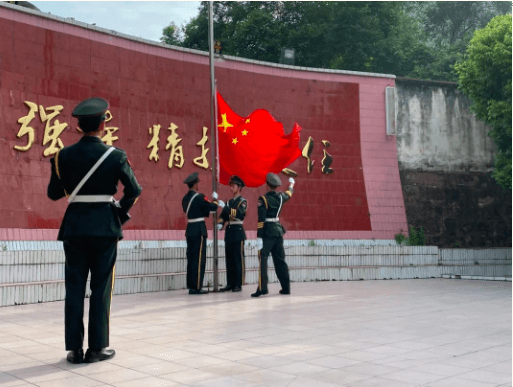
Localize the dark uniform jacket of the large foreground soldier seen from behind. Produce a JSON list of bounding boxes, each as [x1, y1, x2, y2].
[[47, 136, 142, 241]]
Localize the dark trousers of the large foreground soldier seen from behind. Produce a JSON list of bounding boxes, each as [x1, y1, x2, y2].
[[64, 237, 118, 351]]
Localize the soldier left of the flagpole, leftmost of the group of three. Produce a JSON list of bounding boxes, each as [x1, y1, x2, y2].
[[182, 172, 224, 294]]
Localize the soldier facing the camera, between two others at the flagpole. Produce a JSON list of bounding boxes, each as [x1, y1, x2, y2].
[[217, 175, 248, 292]]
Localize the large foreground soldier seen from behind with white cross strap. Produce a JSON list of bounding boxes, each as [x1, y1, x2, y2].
[[48, 98, 142, 364]]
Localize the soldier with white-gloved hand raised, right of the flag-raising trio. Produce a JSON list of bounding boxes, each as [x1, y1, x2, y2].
[[251, 173, 295, 297]]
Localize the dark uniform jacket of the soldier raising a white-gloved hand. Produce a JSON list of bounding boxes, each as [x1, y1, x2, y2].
[[257, 187, 293, 238]]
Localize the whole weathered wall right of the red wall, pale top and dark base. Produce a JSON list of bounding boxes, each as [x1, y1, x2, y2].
[[396, 78, 511, 247]]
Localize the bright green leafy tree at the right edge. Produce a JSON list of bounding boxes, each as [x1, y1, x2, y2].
[[455, 15, 512, 190]]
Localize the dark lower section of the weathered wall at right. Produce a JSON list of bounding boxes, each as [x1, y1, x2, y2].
[[399, 171, 511, 247]]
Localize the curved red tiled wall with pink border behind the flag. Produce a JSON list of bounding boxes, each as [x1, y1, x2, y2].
[[0, 7, 407, 240]]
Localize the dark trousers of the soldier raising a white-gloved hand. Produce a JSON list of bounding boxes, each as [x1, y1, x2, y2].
[[258, 237, 290, 293]]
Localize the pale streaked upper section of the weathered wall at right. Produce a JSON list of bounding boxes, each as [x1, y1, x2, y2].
[[396, 78, 495, 172]]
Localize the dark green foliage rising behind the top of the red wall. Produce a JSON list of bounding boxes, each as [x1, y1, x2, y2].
[[161, 1, 511, 81]]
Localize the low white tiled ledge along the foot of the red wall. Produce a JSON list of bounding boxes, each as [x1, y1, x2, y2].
[[0, 247, 511, 306]]
